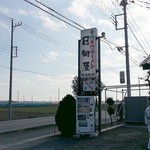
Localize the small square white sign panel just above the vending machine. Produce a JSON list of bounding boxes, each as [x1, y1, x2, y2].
[[83, 79, 95, 91]]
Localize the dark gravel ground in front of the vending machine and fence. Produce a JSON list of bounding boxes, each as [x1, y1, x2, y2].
[[29, 127, 148, 150]]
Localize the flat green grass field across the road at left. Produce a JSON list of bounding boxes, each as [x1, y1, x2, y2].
[[0, 104, 58, 121]]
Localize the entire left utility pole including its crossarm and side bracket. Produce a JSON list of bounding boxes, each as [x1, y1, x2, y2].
[[9, 18, 22, 119]]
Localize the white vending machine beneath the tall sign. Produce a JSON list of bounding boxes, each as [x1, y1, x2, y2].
[[76, 96, 96, 136]]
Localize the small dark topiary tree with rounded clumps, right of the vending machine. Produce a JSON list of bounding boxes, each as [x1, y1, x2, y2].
[[106, 97, 115, 124]]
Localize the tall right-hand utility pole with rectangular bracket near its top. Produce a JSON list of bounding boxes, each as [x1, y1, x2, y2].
[[115, 0, 131, 97]]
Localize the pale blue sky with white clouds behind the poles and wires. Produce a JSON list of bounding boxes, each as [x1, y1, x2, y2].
[[0, 0, 150, 101]]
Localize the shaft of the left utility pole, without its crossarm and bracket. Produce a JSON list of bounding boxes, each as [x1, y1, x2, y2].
[[9, 19, 13, 119]]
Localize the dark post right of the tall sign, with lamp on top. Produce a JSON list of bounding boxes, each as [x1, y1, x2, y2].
[[97, 32, 105, 134]]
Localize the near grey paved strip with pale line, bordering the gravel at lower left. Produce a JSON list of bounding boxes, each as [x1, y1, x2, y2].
[[0, 126, 60, 150]]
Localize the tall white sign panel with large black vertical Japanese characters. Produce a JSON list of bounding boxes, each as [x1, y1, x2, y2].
[[80, 28, 97, 78]]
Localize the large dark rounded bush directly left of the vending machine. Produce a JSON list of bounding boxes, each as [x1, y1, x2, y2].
[[55, 94, 76, 136]]
